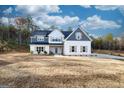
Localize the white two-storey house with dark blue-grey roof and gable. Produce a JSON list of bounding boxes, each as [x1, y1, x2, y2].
[[30, 27, 92, 55]]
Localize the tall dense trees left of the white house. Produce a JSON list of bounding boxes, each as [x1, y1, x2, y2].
[[0, 17, 34, 52]]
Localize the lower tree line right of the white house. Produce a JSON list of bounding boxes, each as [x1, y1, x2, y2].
[[92, 33, 124, 51]]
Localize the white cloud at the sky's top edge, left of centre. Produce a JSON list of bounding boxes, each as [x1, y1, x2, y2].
[[16, 5, 62, 16]]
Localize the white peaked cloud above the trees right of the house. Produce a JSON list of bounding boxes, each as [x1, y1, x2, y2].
[[81, 15, 121, 30]]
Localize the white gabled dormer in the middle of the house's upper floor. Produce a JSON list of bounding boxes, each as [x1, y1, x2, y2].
[[48, 30, 64, 43]]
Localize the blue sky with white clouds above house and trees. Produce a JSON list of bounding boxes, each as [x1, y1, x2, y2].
[[0, 5, 124, 37]]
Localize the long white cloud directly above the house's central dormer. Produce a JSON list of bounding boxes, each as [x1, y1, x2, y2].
[[33, 14, 79, 28]]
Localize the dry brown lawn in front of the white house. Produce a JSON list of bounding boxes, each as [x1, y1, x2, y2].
[[0, 53, 124, 88]]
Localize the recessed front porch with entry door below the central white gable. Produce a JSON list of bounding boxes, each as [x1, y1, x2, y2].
[[49, 45, 63, 55]]
